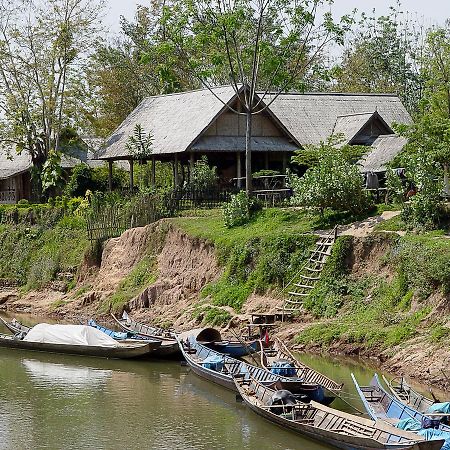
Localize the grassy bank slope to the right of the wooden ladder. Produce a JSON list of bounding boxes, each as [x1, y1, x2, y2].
[[296, 232, 450, 349]]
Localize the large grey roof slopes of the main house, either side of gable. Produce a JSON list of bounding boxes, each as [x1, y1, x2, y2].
[[99, 86, 411, 159]]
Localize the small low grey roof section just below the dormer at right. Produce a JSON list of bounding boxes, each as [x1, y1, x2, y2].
[[358, 134, 407, 173]]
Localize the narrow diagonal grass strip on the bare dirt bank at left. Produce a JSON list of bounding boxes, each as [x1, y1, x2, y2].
[[99, 255, 158, 313]]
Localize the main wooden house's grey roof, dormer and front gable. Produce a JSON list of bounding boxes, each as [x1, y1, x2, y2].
[[99, 86, 411, 188]]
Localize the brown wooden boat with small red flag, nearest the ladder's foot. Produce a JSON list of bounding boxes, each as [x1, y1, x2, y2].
[[260, 338, 344, 394]]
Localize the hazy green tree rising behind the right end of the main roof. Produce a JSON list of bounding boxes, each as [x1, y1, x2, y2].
[[334, 3, 423, 112]]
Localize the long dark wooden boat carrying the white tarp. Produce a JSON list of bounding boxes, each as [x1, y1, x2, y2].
[[0, 334, 151, 359]]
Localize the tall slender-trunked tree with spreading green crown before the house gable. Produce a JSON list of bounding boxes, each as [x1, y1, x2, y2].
[[163, 0, 352, 193]]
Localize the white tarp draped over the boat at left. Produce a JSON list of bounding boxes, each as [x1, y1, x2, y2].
[[24, 323, 120, 347]]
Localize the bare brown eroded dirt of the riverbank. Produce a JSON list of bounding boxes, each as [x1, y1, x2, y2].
[[0, 220, 450, 389]]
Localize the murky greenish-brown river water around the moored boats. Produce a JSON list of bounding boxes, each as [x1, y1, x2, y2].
[[0, 312, 442, 450]]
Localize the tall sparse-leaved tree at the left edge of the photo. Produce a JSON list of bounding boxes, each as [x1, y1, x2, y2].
[[0, 0, 102, 193]]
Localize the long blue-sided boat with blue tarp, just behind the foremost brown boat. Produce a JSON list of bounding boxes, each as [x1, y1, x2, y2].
[[177, 334, 333, 403]]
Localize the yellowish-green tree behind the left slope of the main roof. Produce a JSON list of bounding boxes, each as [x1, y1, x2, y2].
[[85, 1, 194, 136]]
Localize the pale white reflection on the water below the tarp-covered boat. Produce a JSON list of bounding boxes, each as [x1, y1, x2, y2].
[[22, 359, 113, 395]]
